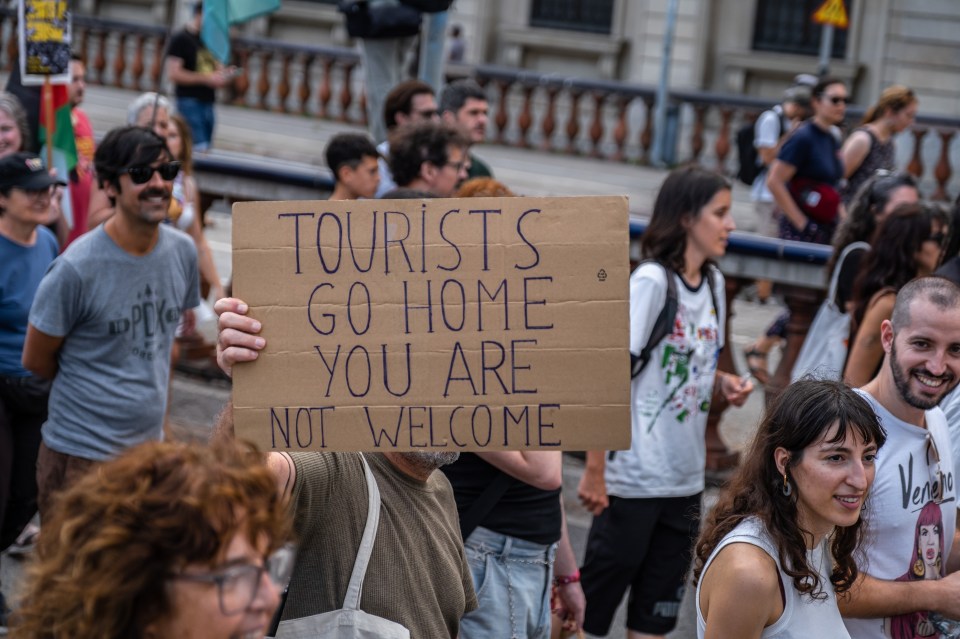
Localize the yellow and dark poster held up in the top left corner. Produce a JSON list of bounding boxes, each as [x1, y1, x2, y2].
[[17, 0, 71, 85]]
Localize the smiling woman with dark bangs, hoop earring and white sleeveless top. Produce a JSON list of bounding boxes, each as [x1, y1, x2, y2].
[[694, 379, 886, 639]]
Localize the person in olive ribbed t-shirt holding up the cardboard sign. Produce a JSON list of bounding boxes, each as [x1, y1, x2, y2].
[[214, 308, 477, 639]]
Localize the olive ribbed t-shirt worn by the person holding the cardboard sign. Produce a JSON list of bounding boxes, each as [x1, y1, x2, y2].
[[283, 452, 477, 639]]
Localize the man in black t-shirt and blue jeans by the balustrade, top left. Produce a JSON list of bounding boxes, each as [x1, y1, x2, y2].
[[164, 2, 235, 151]]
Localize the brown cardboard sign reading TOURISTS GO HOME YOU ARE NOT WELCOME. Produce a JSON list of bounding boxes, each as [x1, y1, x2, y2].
[[233, 197, 630, 451]]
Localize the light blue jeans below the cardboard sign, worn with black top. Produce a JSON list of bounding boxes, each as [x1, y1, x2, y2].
[[460, 528, 557, 639]]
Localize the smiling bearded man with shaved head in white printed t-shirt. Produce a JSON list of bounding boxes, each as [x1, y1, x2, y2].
[[844, 277, 960, 639]]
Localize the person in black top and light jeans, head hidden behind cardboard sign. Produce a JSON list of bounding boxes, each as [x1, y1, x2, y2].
[[441, 451, 586, 639]]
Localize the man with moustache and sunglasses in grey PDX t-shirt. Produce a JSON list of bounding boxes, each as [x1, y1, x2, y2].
[[23, 127, 200, 520]]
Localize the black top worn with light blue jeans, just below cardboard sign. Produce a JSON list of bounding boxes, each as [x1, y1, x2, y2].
[[442, 453, 563, 544]]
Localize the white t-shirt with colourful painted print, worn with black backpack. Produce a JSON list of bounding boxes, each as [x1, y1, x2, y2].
[[605, 263, 726, 498]]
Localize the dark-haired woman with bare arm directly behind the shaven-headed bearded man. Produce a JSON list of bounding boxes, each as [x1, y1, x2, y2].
[[843, 204, 948, 387]]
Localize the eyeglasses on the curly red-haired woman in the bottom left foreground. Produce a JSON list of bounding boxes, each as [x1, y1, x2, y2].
[[170, 544, 296, 616]]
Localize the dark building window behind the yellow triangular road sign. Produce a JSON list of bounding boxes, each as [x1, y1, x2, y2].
[[753, 0, 853, 58]]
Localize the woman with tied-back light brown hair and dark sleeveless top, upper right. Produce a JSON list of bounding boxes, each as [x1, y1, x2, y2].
[[840, 84, 917, 206]]
